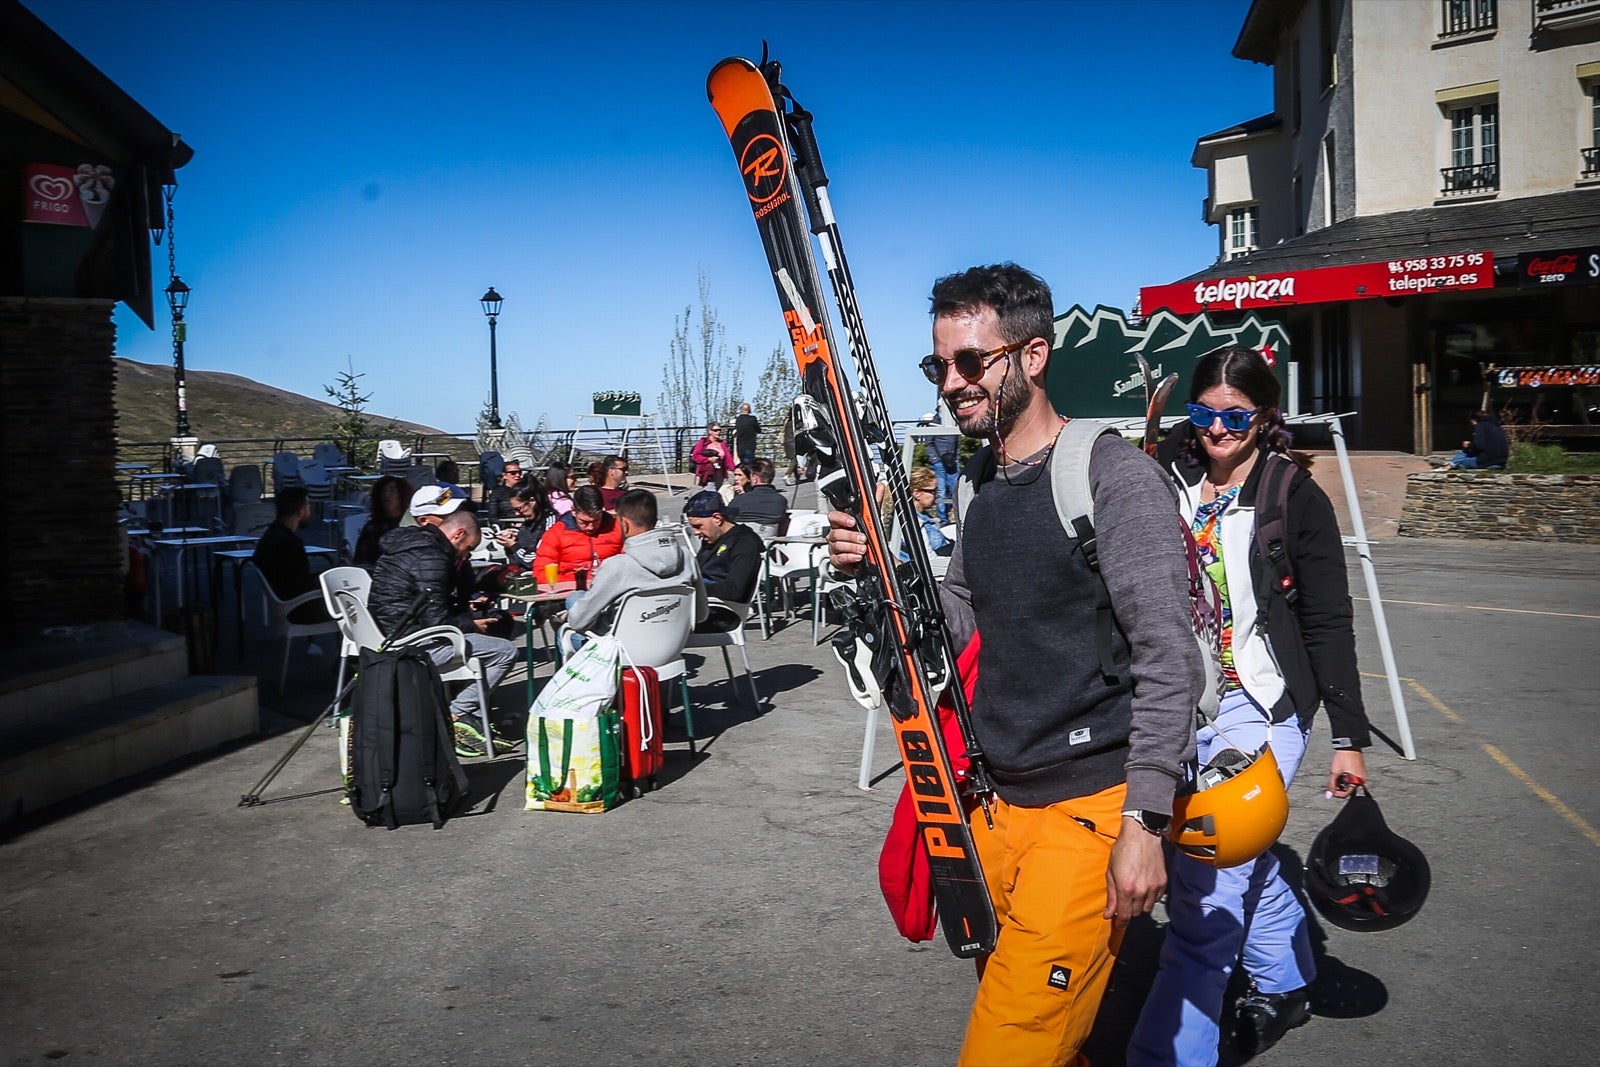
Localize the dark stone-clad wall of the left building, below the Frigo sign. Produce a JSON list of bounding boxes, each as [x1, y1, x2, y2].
[[0, 298, 125, 645]]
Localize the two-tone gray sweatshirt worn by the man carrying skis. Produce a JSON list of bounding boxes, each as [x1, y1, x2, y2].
[[941, 437, 1203, 811]]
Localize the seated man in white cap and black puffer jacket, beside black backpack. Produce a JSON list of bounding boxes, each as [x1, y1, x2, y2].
[[366, 505, 517, 757]]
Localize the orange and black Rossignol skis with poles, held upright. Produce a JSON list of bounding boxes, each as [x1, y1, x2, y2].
[[706, 58, 997, 957]]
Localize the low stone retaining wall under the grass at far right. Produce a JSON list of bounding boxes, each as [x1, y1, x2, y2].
[[1400, 470, 1600, 544]]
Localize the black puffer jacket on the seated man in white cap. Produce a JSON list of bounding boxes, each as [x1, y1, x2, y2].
[[366, 526, 475, 637]]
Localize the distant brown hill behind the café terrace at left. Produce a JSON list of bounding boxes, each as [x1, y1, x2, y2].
[[117, 360, 445, 442]]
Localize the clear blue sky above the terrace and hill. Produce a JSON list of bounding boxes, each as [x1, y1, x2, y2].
[[26, 0, 1272, 430]]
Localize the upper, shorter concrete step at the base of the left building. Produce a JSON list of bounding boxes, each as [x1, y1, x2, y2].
[[0, 622, 189, 731]]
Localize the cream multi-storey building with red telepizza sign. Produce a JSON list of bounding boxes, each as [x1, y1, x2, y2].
[[1141, 0, 1600, 453]]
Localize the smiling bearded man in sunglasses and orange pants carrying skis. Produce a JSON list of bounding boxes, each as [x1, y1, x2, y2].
[[829, 264, 1203, 1067]]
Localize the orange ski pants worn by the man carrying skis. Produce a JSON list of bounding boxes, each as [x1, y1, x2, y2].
[[958, 784, 1128, 1067]]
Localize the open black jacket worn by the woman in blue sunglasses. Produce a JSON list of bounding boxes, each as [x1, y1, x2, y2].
[[1157, 422, 1371, 749]]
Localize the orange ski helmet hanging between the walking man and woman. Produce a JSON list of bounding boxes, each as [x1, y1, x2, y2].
[[1166, 745, 1290, 867]]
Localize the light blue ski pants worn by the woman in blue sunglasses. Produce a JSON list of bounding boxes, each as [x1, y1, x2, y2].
[[1128, 689, 1317, 1067]]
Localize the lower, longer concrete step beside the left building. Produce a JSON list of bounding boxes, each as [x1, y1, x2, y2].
[[0, 681, 261, 822]]
